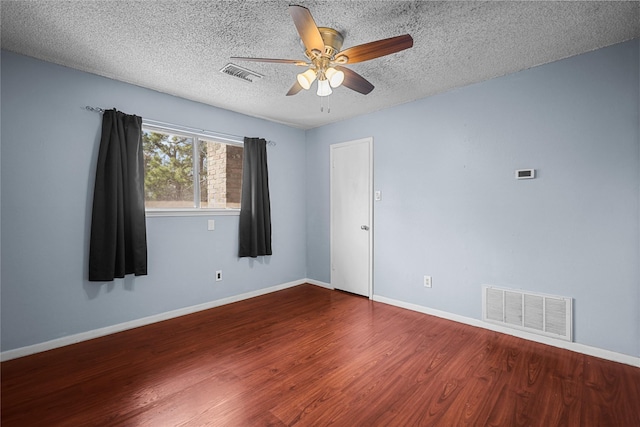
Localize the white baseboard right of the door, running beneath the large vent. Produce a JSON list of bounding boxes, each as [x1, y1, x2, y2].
[[373, 295, 640, 367]]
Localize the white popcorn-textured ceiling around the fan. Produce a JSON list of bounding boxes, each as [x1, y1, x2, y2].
[[0, 0, 640, 129]]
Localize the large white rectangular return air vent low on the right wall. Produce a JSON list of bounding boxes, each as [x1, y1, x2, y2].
[[482, 285, 573, 341]]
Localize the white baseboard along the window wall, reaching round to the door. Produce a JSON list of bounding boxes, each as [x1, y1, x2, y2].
[[0, 279, 314, 362]]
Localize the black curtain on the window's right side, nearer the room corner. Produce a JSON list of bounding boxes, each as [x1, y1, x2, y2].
[[238, 138, 271, 258]]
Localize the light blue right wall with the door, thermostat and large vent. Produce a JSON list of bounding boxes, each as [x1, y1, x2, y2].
[[307, 40, 640, 356]]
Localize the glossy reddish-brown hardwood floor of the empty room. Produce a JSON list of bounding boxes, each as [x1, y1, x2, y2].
[[2, 285, 640, 427]]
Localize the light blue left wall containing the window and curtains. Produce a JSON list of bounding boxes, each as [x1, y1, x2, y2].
[[1, 51, 306, 351]]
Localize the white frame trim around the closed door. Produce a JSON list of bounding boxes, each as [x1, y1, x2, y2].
[[329, 136, 374, 299]]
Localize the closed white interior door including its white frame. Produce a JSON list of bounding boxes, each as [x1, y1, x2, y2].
[[330, 138, 373, 298]]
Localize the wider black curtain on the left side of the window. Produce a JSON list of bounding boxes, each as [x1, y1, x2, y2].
[[89, 110, 147, 282]]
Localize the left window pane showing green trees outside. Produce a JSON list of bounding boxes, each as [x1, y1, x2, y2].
[[143, 130, 194, 208]]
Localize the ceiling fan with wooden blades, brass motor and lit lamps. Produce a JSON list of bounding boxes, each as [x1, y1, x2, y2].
[[231, 5, 413, 96]]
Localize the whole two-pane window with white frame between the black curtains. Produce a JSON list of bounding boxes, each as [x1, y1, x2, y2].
[[142, 125, 243, 211]]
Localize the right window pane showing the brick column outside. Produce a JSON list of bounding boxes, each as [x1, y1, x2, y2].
[[200, 140, 243, 209]]
